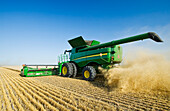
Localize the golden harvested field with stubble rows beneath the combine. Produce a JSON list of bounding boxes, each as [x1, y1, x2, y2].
[[0, 67, 170, 111]]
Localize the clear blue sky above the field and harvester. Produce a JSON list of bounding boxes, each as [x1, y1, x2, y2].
[[0, 0, 170, 65]]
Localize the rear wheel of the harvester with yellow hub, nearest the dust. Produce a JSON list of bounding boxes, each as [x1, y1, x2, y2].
[[82, 66, 96, 81]]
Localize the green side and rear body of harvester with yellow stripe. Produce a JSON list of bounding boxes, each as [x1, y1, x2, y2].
[[70, 46, 122, 67]]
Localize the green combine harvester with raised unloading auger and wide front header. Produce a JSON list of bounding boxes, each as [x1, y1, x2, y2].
[[21, 32, 163, 81]]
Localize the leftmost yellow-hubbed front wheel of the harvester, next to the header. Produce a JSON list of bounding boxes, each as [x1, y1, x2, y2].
[[61, 63, 73, 77]]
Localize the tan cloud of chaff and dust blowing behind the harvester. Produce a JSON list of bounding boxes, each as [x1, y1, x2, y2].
[[101, 50, 170, 94]]
